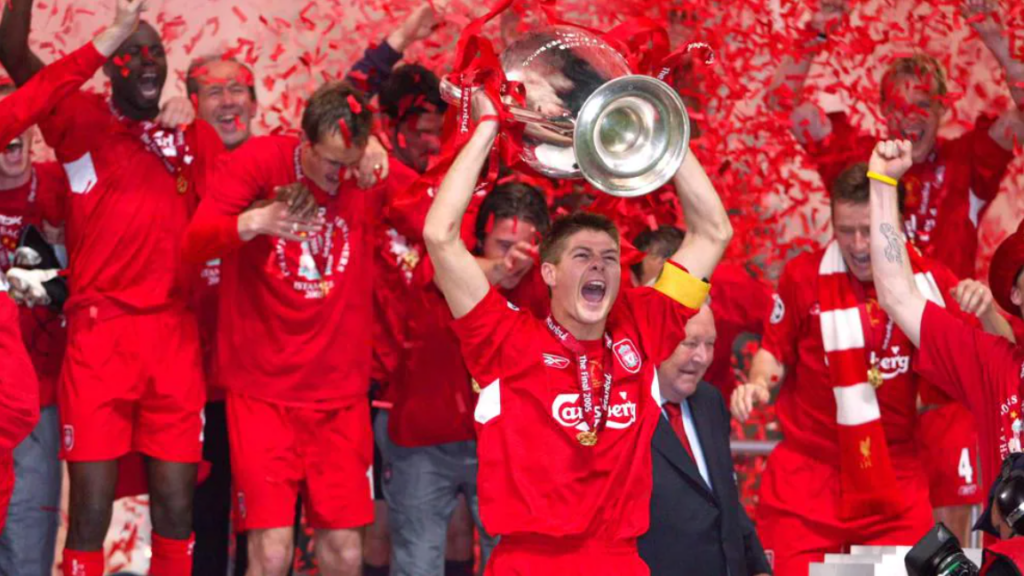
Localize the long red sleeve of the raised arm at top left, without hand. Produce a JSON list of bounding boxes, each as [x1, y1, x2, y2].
[[0, 42, 105, 148]]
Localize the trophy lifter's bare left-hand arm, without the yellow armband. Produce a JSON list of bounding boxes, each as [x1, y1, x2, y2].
[[423, 93, 498, 319]]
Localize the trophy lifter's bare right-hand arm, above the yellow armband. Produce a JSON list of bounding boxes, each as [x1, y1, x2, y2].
[[672, 146, 732, 278]]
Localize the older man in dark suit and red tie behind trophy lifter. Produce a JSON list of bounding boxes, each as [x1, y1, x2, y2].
[[640, 304, 771, 576]]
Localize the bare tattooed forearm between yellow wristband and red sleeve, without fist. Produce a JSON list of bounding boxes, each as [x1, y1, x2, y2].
[[870, 180, 927, 346]]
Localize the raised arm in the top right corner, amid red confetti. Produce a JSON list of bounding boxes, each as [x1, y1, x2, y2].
[[961, 0, 1024, 150]]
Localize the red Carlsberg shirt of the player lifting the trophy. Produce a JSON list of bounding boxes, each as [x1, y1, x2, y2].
[[454, 276, 695, 541]]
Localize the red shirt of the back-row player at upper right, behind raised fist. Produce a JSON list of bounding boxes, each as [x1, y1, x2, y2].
[[807, 113, 1014, 278]]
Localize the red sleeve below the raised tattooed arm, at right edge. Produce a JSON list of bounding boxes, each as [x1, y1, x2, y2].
[[918, 302, 1020, 419]]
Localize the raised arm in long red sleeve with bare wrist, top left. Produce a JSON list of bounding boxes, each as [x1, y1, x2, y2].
[[0, 0, 146, 147]]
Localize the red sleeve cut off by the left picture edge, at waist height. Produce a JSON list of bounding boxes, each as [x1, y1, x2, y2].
[[0, 293, 39, 452]]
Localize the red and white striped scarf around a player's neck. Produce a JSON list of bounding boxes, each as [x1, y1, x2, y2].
[[818, 240, 945, 519]]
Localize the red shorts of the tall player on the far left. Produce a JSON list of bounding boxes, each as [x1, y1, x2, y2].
[[58, 311, 206, 462]]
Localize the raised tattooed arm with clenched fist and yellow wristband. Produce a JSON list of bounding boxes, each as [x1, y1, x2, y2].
[[868, 140, 928, 346]]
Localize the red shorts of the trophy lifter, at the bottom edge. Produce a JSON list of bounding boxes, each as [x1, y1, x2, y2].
[[483, 535, 650, 576]]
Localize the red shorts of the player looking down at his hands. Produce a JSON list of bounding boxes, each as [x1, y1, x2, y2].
[[227, 392, 374, 530]]
